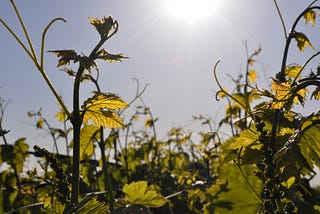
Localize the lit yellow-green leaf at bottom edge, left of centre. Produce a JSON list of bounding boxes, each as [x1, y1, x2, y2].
[[122, 181, 168, 207]]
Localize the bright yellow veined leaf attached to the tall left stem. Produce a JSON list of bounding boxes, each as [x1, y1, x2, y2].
[[82, 93, 128, 128]]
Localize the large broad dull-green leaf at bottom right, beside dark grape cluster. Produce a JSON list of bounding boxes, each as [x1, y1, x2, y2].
[[203, 163, 263, 214]]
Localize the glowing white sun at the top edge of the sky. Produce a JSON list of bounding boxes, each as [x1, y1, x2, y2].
[[165, 0, 219, 22]]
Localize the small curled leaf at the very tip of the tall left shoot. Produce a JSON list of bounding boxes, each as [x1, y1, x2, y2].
[[89, 16, 115, 39]]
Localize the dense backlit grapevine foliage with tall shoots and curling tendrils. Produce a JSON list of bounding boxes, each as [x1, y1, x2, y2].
[[0, 1, 320, 214]]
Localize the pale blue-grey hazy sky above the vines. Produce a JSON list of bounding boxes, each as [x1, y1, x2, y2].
[[0, 0, 320, 179]]
